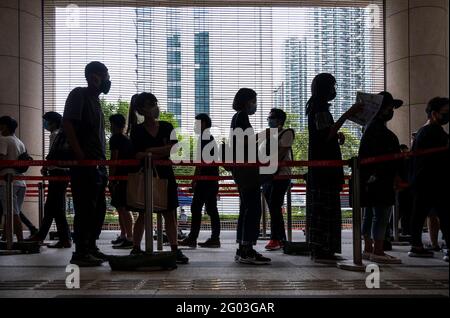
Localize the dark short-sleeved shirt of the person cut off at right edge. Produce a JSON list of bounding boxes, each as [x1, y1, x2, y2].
[[411, 124, 450, 202]]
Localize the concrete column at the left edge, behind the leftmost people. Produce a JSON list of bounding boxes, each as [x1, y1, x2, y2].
[[0, 0, 43, 224]]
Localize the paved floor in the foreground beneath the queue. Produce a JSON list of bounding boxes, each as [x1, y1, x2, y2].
[[0, 231, 449, 297]]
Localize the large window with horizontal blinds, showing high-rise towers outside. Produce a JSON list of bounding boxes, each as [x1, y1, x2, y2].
[[44, 0, 384, 211]]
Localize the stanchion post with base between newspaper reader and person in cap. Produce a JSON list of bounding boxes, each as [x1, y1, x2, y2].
[[337, 157, 365, 272]]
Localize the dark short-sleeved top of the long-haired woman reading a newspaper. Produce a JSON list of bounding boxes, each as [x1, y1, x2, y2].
[[307, 103, 344, 189]]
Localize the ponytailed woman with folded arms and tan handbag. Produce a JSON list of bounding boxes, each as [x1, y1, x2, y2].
[[129, 93, 189, 264]]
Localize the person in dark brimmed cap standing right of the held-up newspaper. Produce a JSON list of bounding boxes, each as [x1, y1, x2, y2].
[[359, 92, 403, 264]]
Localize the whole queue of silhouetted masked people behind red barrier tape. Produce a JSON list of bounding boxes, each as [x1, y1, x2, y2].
[[0, 62, 449, 266]]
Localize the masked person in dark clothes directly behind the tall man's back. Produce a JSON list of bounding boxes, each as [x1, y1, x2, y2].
[[27, 112, 72, 248]]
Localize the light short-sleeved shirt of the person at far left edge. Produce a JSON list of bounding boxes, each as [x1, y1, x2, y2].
[[0, 135, 26, 187]]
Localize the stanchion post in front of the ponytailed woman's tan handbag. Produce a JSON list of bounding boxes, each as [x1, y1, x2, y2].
[[144, 154, 153, 253]]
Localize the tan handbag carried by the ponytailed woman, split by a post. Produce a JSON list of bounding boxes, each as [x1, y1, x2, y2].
[[127, 169, 168, 211]]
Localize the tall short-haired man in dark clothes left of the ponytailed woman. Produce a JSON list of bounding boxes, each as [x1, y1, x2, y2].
[[63, 62, 111, 267]]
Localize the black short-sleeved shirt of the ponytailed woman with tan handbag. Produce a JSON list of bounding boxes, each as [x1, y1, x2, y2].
[[130, 121, 178, 179]]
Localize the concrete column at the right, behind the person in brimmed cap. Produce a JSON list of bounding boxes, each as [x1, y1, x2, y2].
[[386, 0, 449, 145]]
